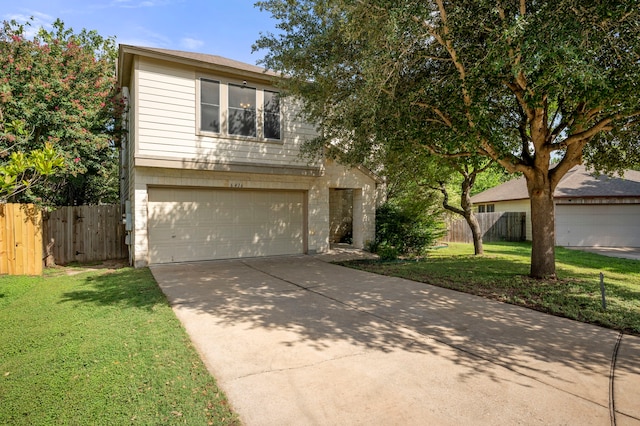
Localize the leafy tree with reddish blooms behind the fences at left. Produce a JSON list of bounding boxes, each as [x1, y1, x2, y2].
[[0, 20, 123, 205]]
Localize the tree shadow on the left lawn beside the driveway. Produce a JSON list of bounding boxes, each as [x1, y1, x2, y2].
[[61, 268, 167, 309]]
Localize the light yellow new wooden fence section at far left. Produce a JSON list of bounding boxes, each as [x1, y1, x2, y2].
[[0, 204, 42, 275]]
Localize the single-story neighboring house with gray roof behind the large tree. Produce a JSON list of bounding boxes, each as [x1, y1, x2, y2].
[[471, 166, 640, 247]]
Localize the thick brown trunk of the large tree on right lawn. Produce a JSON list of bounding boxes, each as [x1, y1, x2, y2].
[[527, 183, 556, 279]]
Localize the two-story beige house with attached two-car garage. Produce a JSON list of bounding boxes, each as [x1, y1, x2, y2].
[[118, 45, 378, 267]]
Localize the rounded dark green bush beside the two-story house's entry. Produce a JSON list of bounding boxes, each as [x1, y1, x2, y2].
[[371, 202, 444, 260]]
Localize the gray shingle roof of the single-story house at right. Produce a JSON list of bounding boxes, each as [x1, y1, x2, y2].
[[471, 166, 640, 203]]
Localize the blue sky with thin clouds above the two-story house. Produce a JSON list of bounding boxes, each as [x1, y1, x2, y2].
[[0, 0, 276, 64]]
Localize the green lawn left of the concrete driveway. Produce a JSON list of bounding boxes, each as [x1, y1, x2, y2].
[[0, 268, 239, 425]]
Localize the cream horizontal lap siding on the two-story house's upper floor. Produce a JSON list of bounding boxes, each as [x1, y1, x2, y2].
[[135, 58, 316, 167]]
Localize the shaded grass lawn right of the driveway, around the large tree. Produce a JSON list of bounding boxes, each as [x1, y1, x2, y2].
[[341, 243, 640, 335]]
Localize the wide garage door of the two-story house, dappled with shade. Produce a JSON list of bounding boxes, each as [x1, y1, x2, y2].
[[148, 188, 304, 263]]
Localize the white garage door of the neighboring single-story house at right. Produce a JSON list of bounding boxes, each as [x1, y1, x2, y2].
[[556, 204, 640, 247]]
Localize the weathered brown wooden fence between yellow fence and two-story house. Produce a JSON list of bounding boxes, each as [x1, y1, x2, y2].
[[43, 205, 127, 266]]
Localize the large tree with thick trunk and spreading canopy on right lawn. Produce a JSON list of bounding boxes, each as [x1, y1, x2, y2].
[[256, 0, 640, 278]]
